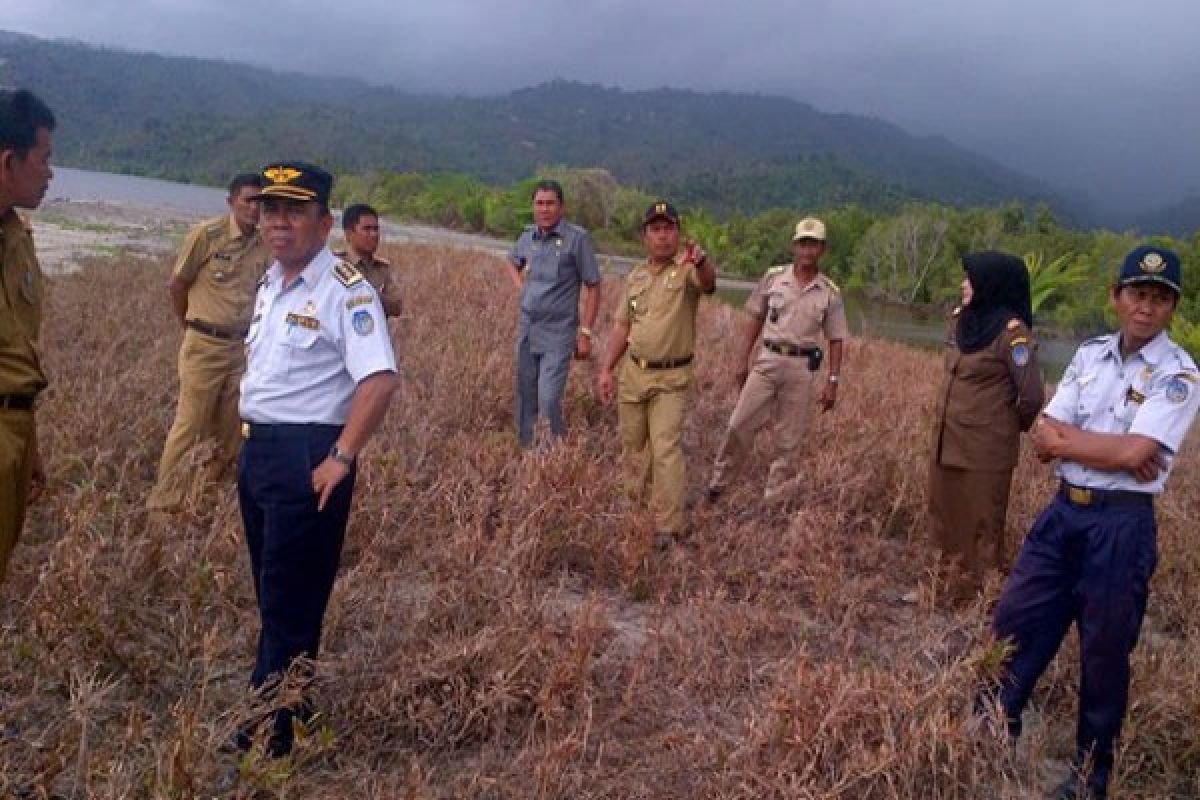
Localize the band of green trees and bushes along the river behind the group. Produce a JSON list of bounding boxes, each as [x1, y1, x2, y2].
[[335, 167, 1200, 354]]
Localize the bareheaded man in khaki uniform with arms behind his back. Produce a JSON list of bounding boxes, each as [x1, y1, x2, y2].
[[146, 174, 269, 511]]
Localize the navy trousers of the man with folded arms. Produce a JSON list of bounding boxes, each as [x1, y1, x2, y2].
[[995, 494, 1158, 777]]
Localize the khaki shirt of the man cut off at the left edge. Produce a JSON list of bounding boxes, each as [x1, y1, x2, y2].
[[0, 209, 47, 396]]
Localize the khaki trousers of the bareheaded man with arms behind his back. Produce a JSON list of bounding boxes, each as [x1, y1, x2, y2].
[[146, 329, 246, 511]]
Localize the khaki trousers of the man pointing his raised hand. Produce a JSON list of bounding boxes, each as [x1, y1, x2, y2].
[[617, 359, 691, 535]]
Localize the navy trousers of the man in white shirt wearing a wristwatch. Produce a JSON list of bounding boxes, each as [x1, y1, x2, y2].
[[238, 425, 355, 688]]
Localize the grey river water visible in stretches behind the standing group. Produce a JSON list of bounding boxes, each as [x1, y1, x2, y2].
[[46, 167, 1078, 379]]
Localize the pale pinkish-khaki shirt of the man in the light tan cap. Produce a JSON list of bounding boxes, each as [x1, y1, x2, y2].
[[746, 265, 850, 353]]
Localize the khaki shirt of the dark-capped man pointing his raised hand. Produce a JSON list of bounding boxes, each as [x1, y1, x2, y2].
[[617, 256, 704, 361]]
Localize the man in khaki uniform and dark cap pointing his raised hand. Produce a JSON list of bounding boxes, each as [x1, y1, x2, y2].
[[598, 201, 716, 543]]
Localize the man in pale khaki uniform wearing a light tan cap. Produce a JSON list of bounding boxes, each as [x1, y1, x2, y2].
[[708, 217, 850, 500]]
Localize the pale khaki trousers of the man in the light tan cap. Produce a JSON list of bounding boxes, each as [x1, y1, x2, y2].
[[709, 353, 817, 494]]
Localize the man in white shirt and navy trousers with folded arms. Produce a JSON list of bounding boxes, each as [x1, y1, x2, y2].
[[994, 246, 1200, 800]]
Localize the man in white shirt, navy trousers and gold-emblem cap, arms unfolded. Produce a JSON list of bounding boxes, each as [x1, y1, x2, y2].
[[236, 162, 398, 757]]
